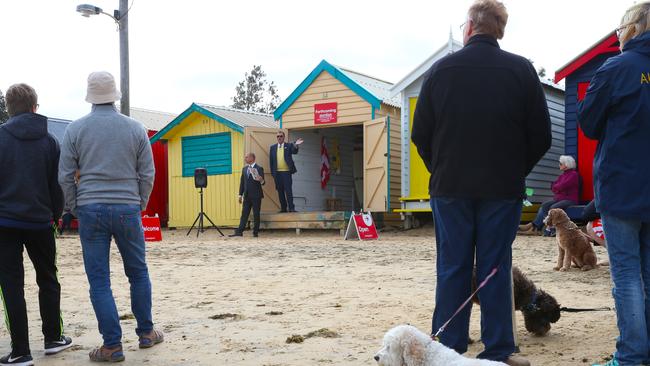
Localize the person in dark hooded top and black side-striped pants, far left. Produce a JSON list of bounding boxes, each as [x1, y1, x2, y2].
[[0, 84, 72, 365]]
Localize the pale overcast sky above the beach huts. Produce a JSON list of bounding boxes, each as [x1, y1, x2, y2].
[[0, 0, 634, 119]]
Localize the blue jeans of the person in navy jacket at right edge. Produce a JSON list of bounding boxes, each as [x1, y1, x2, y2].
[[601, 214, 650, 366]]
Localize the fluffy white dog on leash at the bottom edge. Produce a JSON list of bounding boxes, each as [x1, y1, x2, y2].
[[375, 325, 507, 366]]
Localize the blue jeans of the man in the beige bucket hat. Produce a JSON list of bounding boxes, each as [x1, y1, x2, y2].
[[77, 204, 153, 347]]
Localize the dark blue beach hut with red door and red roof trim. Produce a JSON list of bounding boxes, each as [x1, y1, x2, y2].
[[555, 32, 620, 203]]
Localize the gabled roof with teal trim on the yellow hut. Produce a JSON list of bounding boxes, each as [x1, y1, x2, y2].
[[150, 103, 278, 144]]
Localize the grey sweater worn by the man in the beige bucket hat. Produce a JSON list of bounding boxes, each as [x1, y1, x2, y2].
[[60, 105, 154, 208]]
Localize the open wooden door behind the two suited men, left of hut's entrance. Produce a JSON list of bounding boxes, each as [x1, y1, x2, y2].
[[244, 127, 289, 212]]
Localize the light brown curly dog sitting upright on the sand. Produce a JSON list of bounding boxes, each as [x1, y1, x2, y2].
[[544, 208, 598, 271]]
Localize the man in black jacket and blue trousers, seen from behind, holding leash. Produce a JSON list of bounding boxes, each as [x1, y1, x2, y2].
[[411, 0, 551, 365]]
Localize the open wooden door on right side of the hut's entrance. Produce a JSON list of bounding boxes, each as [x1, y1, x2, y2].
[[363, 117, 390, 212]]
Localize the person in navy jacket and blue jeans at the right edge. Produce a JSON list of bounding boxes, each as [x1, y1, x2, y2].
[[578, 1, 650, 366]]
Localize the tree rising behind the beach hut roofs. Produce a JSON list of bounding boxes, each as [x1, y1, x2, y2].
[[232, 65, 280, 113]]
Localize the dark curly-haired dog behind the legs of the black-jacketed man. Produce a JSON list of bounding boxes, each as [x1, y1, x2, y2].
[[472, 266, 561, 336]]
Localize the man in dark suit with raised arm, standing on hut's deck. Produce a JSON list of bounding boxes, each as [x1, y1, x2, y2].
[[269, 131, 303, 212]]
